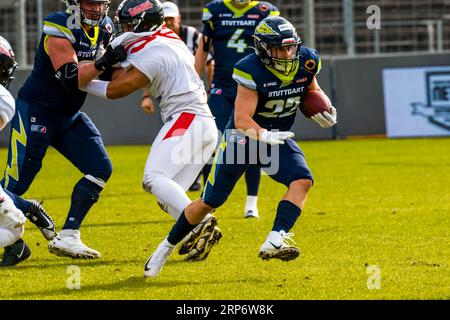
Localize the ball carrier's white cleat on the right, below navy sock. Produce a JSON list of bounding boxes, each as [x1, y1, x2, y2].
[[258, 230, 300, 261]]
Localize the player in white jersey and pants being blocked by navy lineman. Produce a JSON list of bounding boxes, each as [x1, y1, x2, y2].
[[84, 0, 222, 260]]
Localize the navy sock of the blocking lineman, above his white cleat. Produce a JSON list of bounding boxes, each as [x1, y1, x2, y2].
[[63, 177, 103, 230]]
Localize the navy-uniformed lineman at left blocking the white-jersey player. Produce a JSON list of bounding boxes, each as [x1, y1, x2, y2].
[[3, 0, 126, 258]]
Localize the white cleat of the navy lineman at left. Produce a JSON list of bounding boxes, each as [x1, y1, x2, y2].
[[48, 229, 100, 259]]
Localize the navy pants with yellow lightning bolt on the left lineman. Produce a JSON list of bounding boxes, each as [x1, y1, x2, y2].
[[2, 98, 112, 195]]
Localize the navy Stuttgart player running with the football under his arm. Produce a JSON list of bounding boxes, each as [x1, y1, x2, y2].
[[145, 17, 336, 277]]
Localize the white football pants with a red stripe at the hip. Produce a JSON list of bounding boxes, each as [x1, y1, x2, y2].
[[143, 112, 218, 220]]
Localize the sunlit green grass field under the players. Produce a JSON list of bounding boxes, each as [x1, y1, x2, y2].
[[0, 139, 450, 300]]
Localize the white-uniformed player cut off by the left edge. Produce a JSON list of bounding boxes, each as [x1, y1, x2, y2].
[[0, 36, 31, 267]]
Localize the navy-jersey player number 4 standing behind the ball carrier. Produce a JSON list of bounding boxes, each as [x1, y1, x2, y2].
[[195, 0, 280, 218]]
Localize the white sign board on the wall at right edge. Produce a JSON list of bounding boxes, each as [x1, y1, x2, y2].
[[383, 66, 450, 137]]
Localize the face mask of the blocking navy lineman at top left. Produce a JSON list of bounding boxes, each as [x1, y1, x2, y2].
[[65, 0, 111, 26]]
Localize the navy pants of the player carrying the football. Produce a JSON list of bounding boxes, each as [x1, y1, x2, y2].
[[202, 130, 313, 208]]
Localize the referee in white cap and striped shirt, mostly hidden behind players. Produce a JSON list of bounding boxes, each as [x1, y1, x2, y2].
[[141, 1, 214, 191]]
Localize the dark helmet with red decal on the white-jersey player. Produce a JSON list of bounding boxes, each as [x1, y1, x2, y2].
[[114, 0, 164, 34]]
